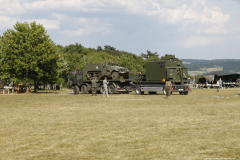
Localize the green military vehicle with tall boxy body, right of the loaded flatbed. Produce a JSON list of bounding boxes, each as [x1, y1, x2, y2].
[[133, 60, 190, 95]]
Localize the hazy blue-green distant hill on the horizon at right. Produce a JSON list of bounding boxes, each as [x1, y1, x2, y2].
[[181, 59, 240, 72]]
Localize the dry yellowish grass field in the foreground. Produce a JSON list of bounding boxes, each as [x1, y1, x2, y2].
[[0, 89, 240, 160]]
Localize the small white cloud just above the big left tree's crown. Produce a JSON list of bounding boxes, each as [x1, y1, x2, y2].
[[22, 19, 60, 30]]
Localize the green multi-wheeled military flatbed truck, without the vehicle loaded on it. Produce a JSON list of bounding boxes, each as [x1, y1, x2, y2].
[[67, 64, 134, 94]]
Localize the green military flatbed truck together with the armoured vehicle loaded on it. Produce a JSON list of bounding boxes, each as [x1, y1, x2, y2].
[[67, 63, 133, 94]]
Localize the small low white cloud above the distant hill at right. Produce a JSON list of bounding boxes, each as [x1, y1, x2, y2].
[[181, 36, 223, 48]]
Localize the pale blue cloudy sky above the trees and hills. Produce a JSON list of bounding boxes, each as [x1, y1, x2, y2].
[[0, 0, 240, 60]]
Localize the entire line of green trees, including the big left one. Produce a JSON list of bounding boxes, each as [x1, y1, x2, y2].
[[0, 22, 178, 89]]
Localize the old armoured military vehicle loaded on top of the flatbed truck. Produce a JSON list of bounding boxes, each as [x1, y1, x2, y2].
[[86, 62, 129, 80]]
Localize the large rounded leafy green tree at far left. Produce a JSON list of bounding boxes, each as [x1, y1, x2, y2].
[[0, 22, 60, 91]]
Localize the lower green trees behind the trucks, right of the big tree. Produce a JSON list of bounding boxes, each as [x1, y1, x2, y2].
[[58, 43, 179, 73]]
